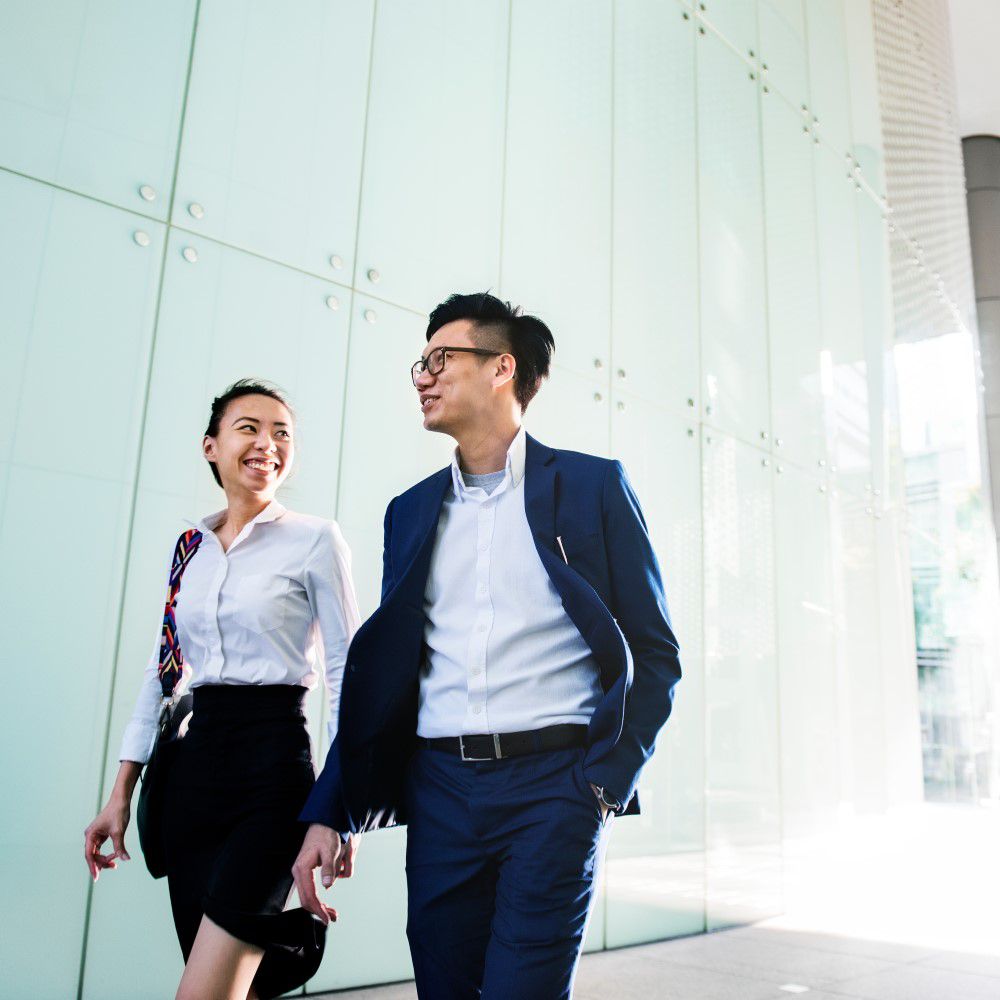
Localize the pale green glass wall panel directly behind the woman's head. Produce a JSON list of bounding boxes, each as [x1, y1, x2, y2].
[[85, 232, 351, 1000]]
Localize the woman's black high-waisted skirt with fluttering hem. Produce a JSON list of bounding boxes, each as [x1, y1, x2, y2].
[[164, 684, 326, 997]]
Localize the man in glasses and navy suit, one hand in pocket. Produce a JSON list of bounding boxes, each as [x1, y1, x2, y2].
[[295, 294, 681, 1000]]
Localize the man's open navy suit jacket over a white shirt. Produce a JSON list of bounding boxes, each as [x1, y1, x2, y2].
[[300, 435, 681, 833]]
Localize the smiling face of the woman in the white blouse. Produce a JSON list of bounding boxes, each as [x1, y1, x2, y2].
[[202, 396, 295, 500]]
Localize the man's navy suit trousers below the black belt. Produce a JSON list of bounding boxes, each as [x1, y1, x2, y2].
[[406, 747, 603, 1000]]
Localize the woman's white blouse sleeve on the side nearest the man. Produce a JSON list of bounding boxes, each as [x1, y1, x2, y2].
[[305, 521, 361, 745]]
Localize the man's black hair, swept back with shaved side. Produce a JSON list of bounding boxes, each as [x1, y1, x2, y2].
[[427, 292, 556, 413]]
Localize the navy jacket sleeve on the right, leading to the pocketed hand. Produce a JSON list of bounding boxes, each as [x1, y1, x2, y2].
[[586, 461, 681, 807]]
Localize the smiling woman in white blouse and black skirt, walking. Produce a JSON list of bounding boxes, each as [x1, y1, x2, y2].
[[84, 381, 358, 1000]]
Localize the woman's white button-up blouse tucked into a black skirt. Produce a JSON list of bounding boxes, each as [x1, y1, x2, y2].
[[119, 501, 359, 763]]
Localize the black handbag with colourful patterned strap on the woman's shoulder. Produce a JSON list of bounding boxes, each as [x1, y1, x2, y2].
[[135, 530, 201, 878]]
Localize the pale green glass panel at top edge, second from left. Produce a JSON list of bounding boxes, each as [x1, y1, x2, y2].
[[173, 0, 372, 284]]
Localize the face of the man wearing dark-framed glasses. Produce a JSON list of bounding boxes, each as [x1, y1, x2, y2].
[[415, 319, 497, 437]]
